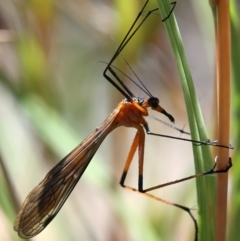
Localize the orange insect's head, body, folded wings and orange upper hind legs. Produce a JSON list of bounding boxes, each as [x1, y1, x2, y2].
[[14, 97, 173, 238]]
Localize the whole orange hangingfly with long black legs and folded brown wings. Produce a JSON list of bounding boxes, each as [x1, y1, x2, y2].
[[14, 0, 231, 240]]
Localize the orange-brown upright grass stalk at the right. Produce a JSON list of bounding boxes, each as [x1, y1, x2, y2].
[[215, 0, 231, 241]]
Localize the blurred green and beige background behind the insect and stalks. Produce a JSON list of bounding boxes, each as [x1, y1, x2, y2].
[[0, 0, 240, 241]]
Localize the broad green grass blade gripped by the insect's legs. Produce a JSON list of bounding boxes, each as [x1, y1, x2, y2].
[[157, 0, 216, 241]]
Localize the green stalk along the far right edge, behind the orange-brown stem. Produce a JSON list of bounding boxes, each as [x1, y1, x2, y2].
[[227, 0, 240, 241]]
